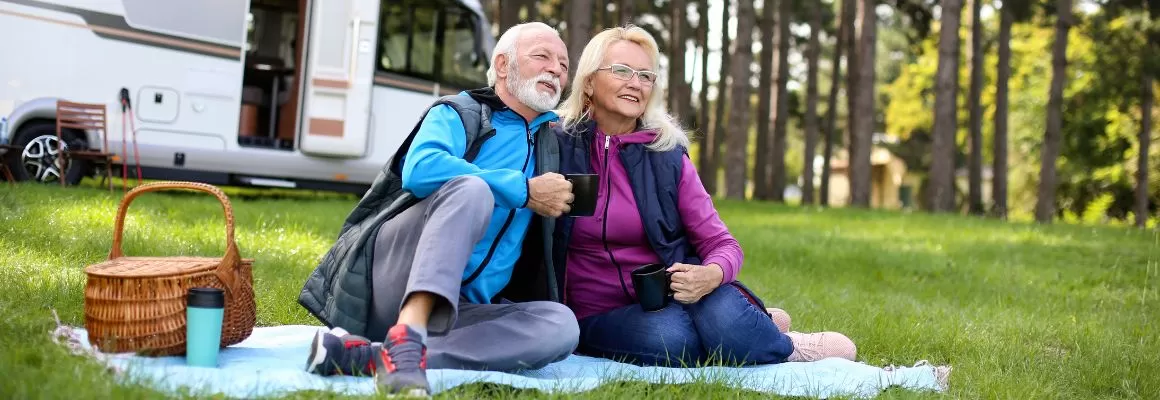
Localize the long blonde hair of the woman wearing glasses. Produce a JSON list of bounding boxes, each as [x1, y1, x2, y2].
[[556, 24, 689, 151]]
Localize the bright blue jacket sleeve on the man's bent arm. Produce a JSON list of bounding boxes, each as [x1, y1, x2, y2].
[[403, 104, 528, 209]]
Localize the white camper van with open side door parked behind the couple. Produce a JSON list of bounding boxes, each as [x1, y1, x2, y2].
[[0, 0, 494, 194]]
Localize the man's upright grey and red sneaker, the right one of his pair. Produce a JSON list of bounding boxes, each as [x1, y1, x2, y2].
[[374, 323, 430, 397]]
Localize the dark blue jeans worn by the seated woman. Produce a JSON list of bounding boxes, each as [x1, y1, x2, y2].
[[577, 283, 793, 368]]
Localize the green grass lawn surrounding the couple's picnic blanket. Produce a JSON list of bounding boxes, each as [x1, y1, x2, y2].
[[0, 186, 1160, 399]]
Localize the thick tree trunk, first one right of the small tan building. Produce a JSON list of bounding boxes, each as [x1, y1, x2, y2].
[[928, 0, 963, 212]]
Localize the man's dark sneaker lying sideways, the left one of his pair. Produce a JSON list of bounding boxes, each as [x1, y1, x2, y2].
[[306, 329, 377, 377]]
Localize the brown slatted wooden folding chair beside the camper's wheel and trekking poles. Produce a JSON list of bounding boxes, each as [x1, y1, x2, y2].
[[57, 100, 115, 191]]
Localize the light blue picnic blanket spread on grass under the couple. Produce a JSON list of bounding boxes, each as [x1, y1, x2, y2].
[[55, 325, 949, 398]]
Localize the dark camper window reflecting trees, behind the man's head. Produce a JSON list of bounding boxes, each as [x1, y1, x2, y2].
[[378, 1, 487, 88]]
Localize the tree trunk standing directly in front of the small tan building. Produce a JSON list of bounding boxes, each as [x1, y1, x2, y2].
[[849, 0, 878, 208]]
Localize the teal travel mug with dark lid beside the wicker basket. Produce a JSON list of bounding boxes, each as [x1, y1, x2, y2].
[[186, 288, 225, 368]]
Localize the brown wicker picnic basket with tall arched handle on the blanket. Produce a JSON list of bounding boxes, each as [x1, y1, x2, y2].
[[85, 182, 255, 356]]
